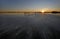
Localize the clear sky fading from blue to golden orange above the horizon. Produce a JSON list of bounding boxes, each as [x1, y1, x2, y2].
[[0, 0, 60, 11]]
